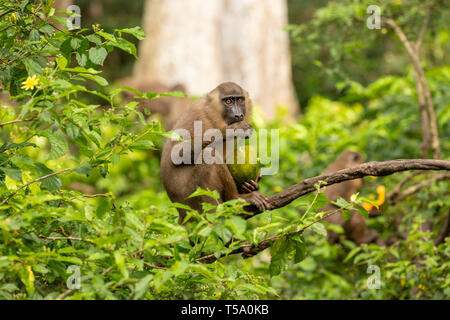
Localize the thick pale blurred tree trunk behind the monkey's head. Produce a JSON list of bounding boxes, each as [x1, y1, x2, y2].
[[134, 0, 298, 119]]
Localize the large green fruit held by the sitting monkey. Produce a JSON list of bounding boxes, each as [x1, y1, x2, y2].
[[227, 145, 261, 187]]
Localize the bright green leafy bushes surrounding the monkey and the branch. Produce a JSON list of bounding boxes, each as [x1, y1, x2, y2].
[[0, 0, 450, 299]]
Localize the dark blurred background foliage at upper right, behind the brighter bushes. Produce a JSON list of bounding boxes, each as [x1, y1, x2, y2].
[[287, 0, 450, 106]]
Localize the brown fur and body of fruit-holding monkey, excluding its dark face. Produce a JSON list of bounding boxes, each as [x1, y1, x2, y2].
[[161, 82, 269, 223]]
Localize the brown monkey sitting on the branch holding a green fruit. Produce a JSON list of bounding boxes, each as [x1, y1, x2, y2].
[[161, 82, 270, 223]]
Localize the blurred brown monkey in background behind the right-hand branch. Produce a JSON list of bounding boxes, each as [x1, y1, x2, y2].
[[322, 150, 379, 244]]
